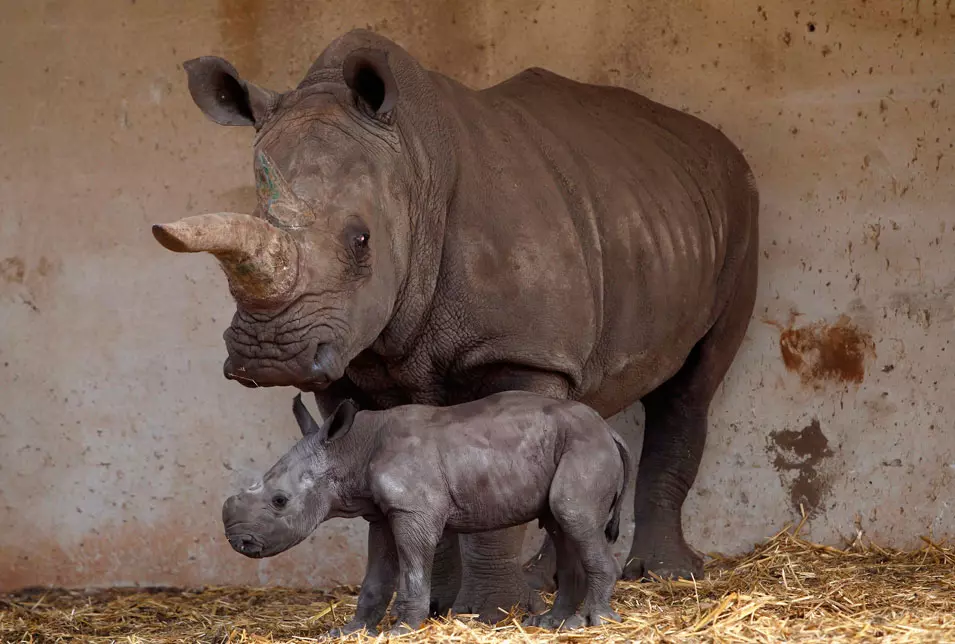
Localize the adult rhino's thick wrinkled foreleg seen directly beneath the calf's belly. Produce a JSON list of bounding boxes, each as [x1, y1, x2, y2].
[[453, 526, 544, 624]]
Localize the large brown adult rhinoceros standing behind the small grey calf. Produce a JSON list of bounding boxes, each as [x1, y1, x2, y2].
[[153, 30, 758, 619]]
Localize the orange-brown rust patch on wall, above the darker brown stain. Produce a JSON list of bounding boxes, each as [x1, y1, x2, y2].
[[764, 313, 875, 386]]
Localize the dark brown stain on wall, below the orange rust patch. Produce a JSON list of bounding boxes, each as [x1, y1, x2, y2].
[[768, 419, 832, 515]]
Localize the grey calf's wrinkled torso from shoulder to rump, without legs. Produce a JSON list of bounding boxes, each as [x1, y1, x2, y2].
[[373, 392, 617, 533]]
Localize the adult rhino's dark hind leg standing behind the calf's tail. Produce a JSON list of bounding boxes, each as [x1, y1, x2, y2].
[[623, 238, 757, 580]]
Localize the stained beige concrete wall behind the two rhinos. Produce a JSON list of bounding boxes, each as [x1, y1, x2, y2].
[[0, 0, 955, 589]]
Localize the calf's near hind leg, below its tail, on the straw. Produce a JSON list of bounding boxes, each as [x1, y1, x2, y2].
[[550, 443, 623, 629]]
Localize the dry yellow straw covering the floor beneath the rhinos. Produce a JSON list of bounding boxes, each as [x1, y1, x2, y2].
[[0, 529, 955, 644]]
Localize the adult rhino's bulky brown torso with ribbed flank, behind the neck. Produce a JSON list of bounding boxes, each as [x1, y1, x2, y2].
[[432, 70, 756, 415]]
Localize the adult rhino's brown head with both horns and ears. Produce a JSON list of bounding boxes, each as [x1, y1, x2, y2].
[[153, 42, 420, 390]]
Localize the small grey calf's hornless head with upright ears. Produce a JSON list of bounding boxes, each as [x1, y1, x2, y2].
[[222, 395, 357, 558]]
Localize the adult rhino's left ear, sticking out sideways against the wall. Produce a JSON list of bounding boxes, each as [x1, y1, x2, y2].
[[182, 56, 279, 130]]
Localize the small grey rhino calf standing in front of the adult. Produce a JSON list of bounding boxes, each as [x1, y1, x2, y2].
[[222, 391, 632, 636]]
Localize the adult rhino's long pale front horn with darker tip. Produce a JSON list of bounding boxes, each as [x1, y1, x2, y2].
[[153, 212, 298, 307]]
